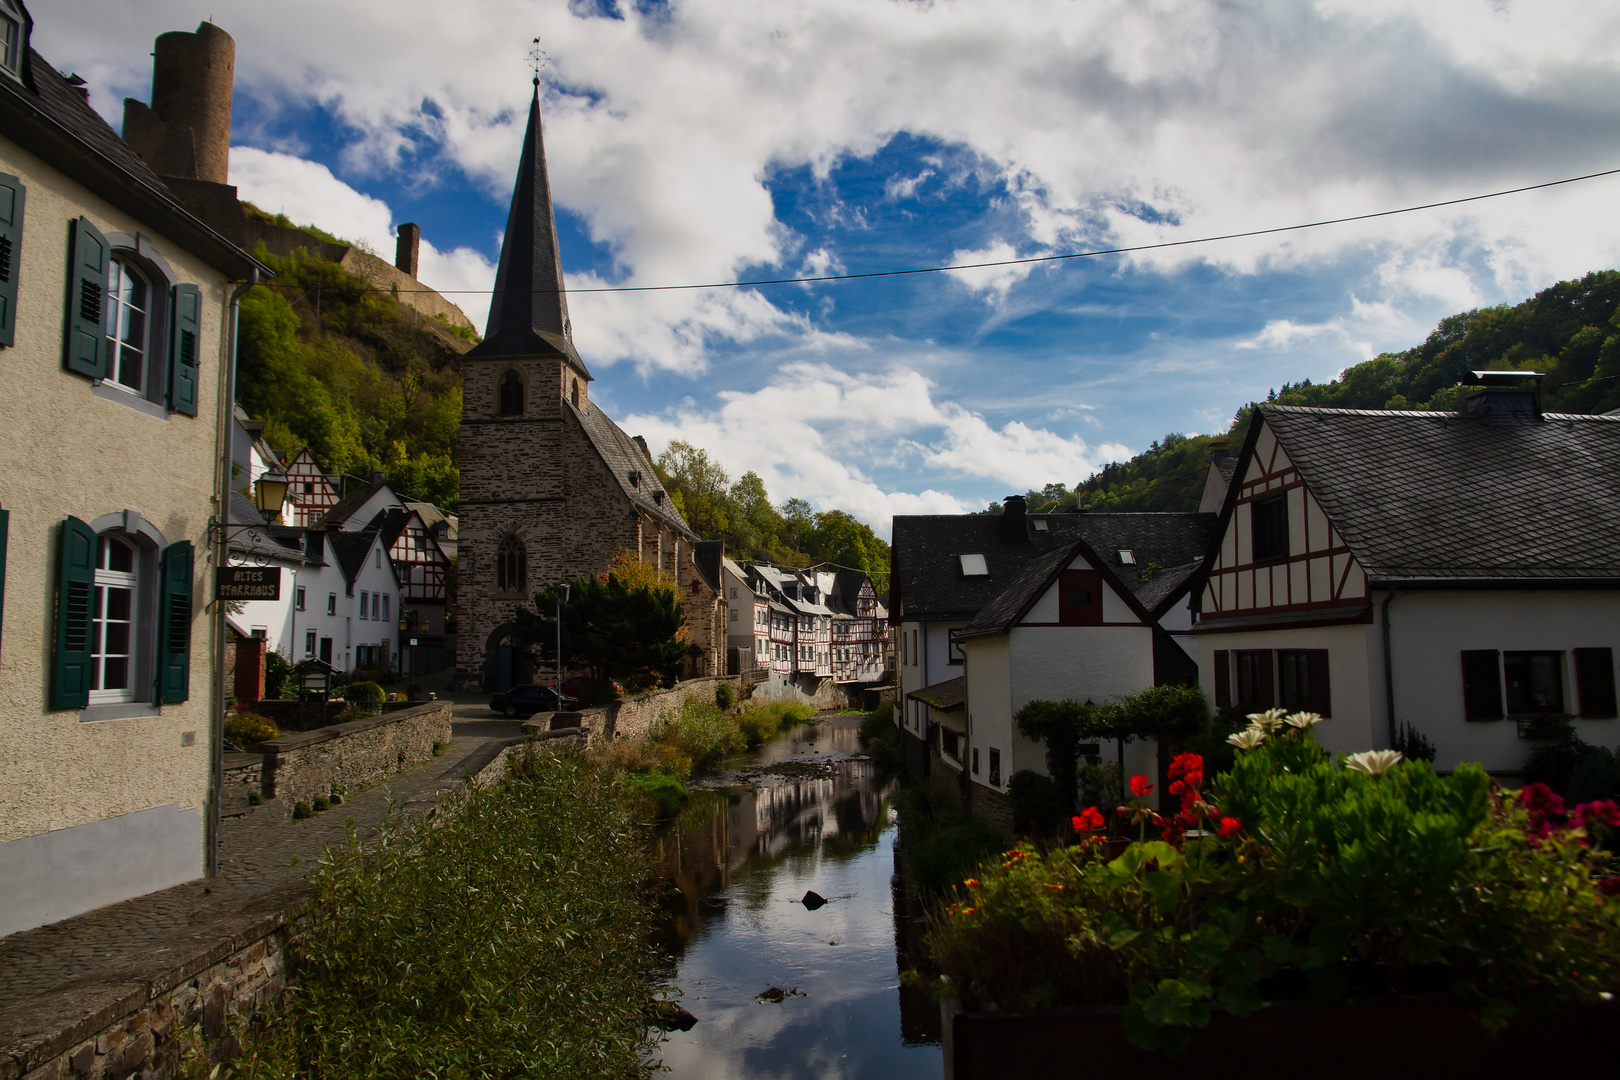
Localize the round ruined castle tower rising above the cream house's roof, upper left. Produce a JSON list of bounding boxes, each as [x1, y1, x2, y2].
[[123, 23, 237, 183]]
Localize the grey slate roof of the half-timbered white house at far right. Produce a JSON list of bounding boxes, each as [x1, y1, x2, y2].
[[1257, 405, 1620, 583]]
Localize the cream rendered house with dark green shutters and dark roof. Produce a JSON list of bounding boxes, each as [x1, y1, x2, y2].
[[0, 5, 264, 934]]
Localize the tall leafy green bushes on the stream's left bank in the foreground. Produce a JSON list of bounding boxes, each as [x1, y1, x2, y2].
[[233, 748, 661, 1080]]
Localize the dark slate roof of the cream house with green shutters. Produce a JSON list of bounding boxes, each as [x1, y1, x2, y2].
[[0, 47, 271, 279]]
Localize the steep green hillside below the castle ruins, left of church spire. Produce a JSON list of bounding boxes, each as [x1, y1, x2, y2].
[[237, 248, 471, 510]]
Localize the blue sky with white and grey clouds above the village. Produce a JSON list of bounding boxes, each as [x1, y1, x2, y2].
[[32, 0, 1620, 534]]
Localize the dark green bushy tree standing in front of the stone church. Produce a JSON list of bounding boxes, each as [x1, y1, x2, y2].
[[514, 563, 687, 690]]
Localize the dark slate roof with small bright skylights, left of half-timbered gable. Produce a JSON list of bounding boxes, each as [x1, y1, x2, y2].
[[889, 513, 1217, 622]]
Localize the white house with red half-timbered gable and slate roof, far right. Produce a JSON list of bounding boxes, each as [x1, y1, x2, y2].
[[1196, 372, 1620, 774]]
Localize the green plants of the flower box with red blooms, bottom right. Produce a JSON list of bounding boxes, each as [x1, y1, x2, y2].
[[928, 727, 1620, 1052]]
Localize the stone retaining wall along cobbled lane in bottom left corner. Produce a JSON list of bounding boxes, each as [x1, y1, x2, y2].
[[0, 882, 309, 1080]]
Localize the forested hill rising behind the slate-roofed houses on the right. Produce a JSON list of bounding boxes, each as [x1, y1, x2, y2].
[[1062, 270, 1620, 510]]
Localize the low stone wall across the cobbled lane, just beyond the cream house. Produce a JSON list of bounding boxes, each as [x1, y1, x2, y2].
[[253, 701, 450, 813]]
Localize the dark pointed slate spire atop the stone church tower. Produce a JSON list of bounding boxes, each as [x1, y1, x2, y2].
[[467, 78, 591, 379]]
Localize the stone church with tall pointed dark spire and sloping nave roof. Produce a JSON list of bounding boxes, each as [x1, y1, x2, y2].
[[455, 79, 726, 690]]
